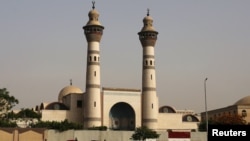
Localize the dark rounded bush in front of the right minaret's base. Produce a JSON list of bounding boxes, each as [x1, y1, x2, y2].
[[131, 126, 160, 140]]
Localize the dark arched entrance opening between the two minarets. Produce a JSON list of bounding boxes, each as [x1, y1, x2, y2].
[[109, 102, 135, 130]]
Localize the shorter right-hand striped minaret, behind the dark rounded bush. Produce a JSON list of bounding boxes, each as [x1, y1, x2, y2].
[[138, 9, 159, 129]]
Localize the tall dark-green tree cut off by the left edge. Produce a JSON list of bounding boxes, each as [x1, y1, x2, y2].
[[0, 88, 18, 118]]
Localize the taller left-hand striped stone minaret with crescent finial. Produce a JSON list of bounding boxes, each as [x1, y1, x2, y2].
[[83, 2, 104, 128]]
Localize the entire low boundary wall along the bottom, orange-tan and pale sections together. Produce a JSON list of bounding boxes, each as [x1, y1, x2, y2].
[[0, 128, 207, 141]]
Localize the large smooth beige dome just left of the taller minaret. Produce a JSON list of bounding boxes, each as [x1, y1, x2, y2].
[[58, 85, 83, 102]]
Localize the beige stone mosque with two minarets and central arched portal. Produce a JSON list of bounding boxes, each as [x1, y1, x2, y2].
[[35, 2, 200, 131]]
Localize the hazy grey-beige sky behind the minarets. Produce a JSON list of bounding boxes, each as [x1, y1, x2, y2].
[[0, 0, 250, 113]]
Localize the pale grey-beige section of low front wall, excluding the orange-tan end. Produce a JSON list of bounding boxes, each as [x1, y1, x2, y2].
[[47, 130, 207, 141]]
